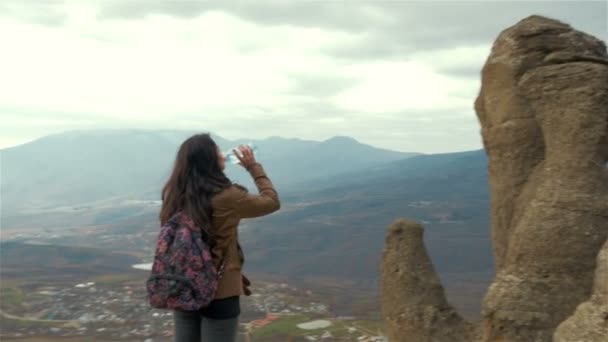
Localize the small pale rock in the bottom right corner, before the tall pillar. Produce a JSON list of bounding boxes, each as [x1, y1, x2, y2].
[[553, 241, 608, 342]]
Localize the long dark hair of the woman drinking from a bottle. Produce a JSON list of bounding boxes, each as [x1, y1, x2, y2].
[[160, 134, 231, 239]]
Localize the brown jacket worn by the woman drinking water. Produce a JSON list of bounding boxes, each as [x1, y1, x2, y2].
[[211, 163, 281, 299]]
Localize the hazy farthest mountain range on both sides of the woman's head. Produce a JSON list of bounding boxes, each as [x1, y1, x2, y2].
[[0, 130, 415, 213]]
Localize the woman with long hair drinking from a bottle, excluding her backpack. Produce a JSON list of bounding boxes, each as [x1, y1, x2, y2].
[[160, 134, 280, 342]]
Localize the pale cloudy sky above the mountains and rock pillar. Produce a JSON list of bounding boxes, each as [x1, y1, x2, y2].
[[0, 0, 608, 153]]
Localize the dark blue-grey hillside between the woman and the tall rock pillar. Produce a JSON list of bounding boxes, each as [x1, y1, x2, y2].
[[241, 151, 493, 312]]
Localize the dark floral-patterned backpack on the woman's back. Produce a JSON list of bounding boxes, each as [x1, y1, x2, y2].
[[146, 211, 224, 311]]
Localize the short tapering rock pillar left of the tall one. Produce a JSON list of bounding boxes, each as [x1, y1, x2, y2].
[[382, 220, 472, 342]]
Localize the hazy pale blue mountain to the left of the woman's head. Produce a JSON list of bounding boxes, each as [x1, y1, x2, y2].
[[0, 130, 186, 209]]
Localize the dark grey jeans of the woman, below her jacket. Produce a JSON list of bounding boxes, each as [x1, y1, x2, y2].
[[173, 311, 239, 342]]
